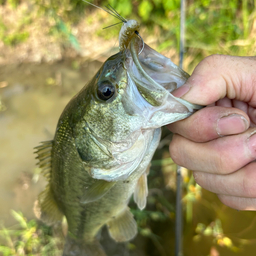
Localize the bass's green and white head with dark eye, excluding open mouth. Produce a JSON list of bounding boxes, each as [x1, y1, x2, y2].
[[70, 51, 152, 181]]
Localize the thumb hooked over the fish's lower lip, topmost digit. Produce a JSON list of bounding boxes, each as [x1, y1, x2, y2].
[[173, 55, 256, 107]]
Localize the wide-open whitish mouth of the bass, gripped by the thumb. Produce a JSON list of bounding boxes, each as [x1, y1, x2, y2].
[[125, 37, 202, 128]]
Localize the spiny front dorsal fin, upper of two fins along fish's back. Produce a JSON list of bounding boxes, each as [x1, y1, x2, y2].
[[34, 140, 53, 181]]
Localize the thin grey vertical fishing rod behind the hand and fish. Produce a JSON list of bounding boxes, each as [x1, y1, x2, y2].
[[175, 0, 185, 256]]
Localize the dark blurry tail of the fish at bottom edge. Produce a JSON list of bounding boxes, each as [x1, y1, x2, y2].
[[62, 235, 107, 256]]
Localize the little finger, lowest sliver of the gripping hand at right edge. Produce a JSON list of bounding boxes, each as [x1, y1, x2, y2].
[[218, 195, 256, 211]]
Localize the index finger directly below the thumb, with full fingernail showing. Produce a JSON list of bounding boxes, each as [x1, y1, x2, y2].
[[167, 107, 250, 142]]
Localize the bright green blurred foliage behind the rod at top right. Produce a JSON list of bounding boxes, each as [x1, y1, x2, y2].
[[83, 0, 256, 69]]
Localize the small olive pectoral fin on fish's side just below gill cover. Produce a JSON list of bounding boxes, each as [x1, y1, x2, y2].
[[80, 180, 116, 204]]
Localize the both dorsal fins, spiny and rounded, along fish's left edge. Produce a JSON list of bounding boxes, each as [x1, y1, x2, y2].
[[34, 140, 63, 225]]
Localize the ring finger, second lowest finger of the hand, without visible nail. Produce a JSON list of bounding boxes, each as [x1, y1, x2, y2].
[[193, 162, 256, 198]]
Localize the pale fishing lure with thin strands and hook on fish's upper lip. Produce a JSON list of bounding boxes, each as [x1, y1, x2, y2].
[[83, 0, 141, 52]]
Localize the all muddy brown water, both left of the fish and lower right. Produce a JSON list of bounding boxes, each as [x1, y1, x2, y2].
[[0, 60, 256, 256]]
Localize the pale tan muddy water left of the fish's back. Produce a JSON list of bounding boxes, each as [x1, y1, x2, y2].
[[0, 61, 101, 226]]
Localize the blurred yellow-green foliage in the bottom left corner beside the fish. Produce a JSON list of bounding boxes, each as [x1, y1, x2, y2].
[[0, 210, 60, 256]]
